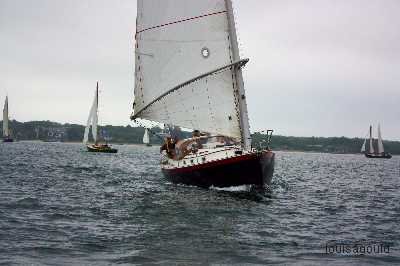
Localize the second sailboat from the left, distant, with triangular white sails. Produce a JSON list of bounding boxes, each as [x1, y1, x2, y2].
[[83, 82, 118, 153]]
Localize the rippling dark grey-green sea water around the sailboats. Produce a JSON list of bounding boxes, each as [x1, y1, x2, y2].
[[0, 142, 400, 265]]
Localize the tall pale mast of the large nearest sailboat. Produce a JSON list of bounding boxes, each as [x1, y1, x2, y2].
[[225, 0, 251, 150]]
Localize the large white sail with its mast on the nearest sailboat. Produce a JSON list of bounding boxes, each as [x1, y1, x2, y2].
[[131, 0, 250, 148]]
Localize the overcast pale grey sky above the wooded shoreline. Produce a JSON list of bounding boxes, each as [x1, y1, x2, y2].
[[0, 0, 400, 140]]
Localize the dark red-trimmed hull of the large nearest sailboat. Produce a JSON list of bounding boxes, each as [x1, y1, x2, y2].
[[162, 151, 275, 188]]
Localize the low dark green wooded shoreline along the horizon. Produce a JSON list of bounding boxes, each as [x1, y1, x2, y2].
[[0, 120, 400, 154]]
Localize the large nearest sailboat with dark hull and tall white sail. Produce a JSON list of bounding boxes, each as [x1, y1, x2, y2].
[[131, 0, 275, 188]]
